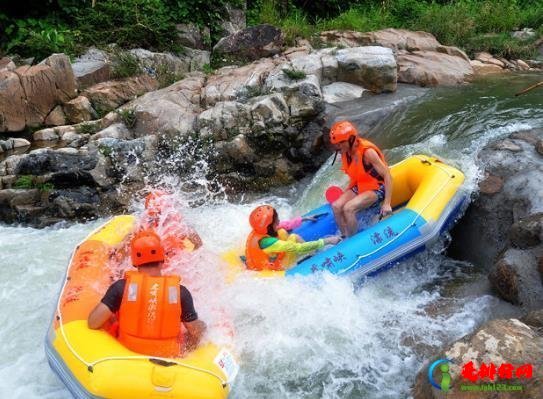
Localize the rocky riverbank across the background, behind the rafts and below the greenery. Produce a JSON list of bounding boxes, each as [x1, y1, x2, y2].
[[0, 25, 540, 226]]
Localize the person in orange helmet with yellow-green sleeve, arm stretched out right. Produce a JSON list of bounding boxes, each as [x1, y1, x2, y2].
[[245, 205, 341, 271]]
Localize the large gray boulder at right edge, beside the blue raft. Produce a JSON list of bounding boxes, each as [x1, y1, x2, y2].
[[449, 129, 543, 270]]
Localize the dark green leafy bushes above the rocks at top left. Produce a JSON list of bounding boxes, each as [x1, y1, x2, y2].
[[0, 0, 243, 59]]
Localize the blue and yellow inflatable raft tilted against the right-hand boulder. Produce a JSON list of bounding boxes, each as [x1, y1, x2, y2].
[[285, 155, 468, 277]]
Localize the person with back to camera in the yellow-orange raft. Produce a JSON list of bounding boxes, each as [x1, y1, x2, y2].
[[87, 231, 206, 357]]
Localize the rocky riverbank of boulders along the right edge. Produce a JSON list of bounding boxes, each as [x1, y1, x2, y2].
[[413, 129, 543, 399]]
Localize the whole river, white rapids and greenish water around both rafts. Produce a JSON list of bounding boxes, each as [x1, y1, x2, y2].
[[0, 74, 543, 399]]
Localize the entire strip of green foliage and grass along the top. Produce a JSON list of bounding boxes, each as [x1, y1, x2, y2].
[[0, 0, 543, 62]]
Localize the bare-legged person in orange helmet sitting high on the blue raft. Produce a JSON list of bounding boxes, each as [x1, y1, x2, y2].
[[330, 121, 392, 237]]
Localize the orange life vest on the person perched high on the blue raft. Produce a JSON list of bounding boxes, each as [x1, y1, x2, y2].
[[341, 137, 387, 193]]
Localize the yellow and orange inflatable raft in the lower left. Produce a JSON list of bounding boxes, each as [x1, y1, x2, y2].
[[45, 216, 238, 399]]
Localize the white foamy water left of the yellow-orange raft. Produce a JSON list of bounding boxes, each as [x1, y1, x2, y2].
[[0, 222, 100, 399]]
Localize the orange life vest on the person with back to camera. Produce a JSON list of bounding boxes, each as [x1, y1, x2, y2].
[[119, 271, 182, 357]]
